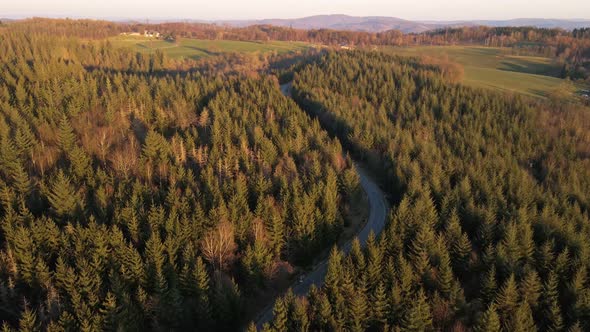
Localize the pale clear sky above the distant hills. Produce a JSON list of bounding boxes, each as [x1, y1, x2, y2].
[[0, 0, 590, 20]]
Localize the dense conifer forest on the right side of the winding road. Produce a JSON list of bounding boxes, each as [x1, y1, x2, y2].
[[264, 52, 590, 331]]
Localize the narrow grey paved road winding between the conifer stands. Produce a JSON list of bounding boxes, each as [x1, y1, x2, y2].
[[256, 82, 389, 329]]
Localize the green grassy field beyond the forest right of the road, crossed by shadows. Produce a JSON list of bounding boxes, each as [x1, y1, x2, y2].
[[383, 46, 575, 97]]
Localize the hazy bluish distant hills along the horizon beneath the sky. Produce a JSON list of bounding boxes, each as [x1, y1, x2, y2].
[[213, 15, 590, 33]]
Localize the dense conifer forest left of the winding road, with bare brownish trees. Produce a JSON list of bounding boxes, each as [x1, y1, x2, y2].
[[0, 30, 359, 331]]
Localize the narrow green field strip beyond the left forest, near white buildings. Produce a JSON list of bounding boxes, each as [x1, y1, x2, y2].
[[110, 36, 311, 59]]
